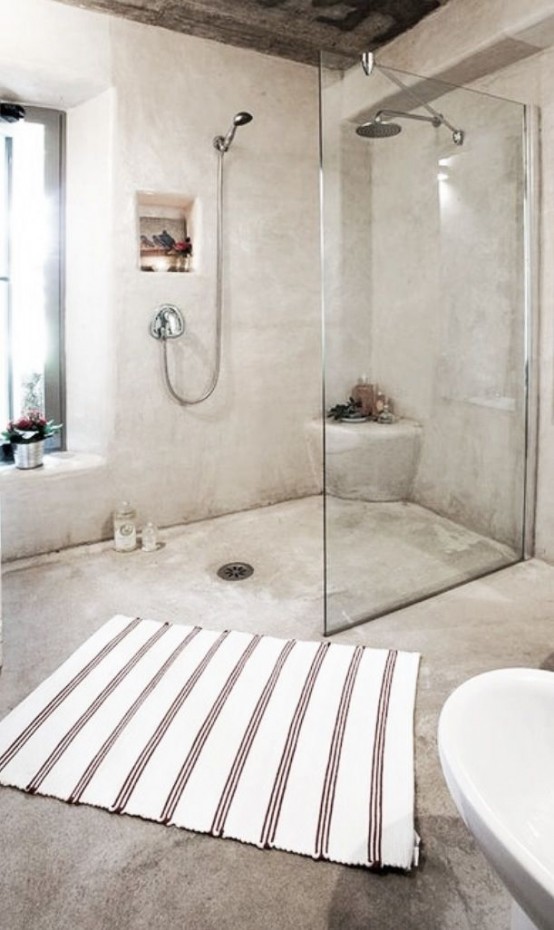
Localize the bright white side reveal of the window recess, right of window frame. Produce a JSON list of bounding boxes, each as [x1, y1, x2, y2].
[[65, 88, 117, 456]]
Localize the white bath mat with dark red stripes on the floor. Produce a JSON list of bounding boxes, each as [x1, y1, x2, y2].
[[0, 616, 419, 869]]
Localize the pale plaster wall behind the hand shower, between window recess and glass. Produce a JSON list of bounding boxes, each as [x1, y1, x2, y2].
[[105, 21, 320, 523]]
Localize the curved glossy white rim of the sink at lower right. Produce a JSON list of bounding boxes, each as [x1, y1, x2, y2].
[[438, 668, 554, 928]]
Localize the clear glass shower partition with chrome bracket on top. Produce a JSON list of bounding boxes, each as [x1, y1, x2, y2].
[[320, 55, 529, 633]]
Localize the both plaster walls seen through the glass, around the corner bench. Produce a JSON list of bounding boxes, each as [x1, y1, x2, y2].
[[316, 54, 525, 551]]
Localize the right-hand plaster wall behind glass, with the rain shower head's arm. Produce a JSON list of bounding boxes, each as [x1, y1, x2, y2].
[[371, 90, 525, 551]]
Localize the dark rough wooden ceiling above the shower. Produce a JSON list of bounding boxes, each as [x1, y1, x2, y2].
[[52, 0, 448, 64]]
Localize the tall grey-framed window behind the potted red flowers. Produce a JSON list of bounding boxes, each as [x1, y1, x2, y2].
[[0, 107, 64, 448]]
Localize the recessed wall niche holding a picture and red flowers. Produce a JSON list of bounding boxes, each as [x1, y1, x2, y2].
[[137, 191, 195, 272]]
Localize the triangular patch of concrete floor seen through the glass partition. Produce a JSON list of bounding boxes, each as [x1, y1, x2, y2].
[[325, 497, 519, 632]]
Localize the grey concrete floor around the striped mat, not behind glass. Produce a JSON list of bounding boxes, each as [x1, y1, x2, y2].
[[0, 499, 554, 930]]
